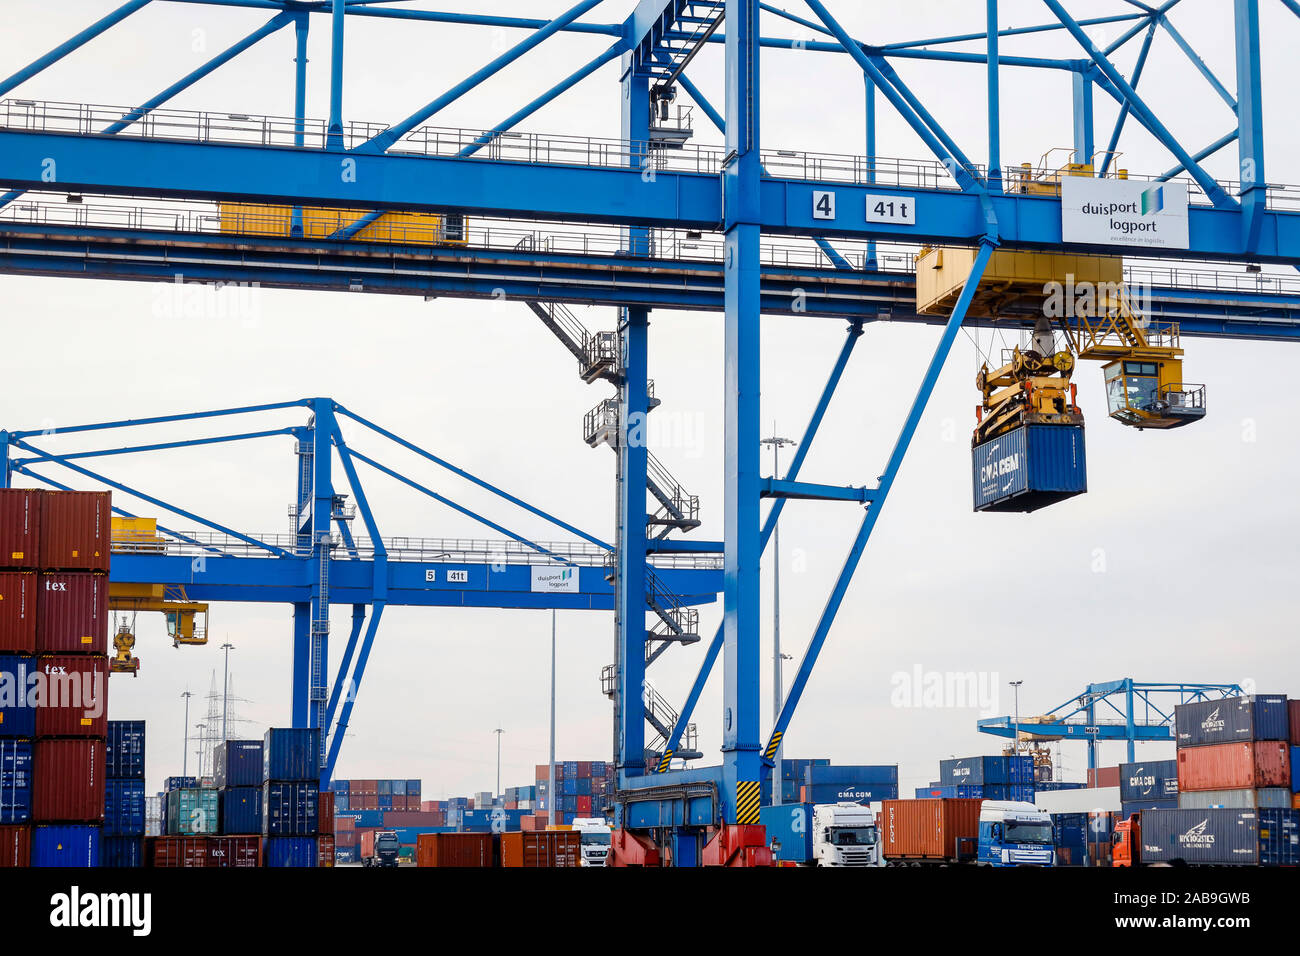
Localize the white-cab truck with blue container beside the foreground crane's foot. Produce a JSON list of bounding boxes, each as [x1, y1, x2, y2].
[[759, 801, 880, 866]]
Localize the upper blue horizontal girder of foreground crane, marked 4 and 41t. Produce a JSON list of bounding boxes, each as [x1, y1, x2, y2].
[[0, 129, 1300, 264]]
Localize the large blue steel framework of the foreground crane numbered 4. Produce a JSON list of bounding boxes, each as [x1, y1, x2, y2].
[[0, 0, 1300, 823]]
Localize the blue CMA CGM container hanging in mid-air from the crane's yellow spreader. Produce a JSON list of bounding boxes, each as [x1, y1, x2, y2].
[[971, 425, 1088, 511]]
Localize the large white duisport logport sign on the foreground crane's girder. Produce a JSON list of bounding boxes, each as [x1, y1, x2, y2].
[[1061, 176, 1191, 248]]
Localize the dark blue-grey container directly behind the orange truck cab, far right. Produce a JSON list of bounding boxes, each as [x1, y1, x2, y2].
[[1140, 809, 1300, 866]]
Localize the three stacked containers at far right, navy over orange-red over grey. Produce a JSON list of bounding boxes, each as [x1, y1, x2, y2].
[[1174, 695, 1292, 810]]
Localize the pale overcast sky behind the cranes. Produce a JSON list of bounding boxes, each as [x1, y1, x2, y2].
[[0, 0, 1300, 797]]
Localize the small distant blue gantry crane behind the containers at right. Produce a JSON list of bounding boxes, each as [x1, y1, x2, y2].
[[976, 678, 1243, 770]]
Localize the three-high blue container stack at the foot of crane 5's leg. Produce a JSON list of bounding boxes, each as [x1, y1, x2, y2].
[[261, 727, 321, 868]]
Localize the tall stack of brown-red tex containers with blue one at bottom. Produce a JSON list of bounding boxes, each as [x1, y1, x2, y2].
[[21, 489, 111, 866]]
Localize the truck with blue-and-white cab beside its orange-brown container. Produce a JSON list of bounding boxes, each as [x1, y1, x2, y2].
[[878, 799, 1056, 866]]
